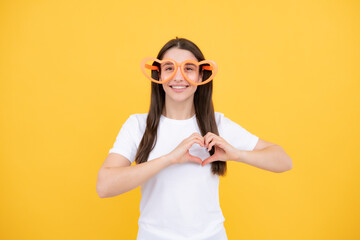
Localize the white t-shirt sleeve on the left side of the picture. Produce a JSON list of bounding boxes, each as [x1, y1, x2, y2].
[[109, 115, 139, 163]]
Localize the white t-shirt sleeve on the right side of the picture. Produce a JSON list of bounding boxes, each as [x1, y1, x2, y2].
[[218, 114, 259, 151]]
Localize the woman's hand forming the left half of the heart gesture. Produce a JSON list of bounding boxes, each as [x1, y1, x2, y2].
[[167, 133, 205, 164]]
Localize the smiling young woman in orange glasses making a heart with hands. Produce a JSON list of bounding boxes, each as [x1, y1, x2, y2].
[[96, 38, 292, 240]]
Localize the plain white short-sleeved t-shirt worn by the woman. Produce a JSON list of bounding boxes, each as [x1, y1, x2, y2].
[[109, 112, 259, 240]]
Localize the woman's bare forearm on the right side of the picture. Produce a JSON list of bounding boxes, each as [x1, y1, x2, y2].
[[236, 145, 292, 173]]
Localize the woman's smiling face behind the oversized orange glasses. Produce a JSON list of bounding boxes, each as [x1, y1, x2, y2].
[[160, 48, 202, 102]]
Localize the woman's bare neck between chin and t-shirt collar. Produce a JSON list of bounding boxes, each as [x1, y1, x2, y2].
[[162, 97, 195, 120]]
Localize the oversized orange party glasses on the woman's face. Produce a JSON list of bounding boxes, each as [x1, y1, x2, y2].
[[140, 57, 218, 85]]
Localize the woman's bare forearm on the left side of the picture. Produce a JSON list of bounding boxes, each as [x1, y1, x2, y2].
[[99, 156, 173, 198]]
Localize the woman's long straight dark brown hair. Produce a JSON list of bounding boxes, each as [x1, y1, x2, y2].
[[135, 37, 227, 176]]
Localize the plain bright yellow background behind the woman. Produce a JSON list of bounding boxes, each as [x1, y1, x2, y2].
[[0, 0, 360, 240]]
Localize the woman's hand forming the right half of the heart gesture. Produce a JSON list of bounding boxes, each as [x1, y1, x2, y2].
[[202, 132, 240, 166]]
